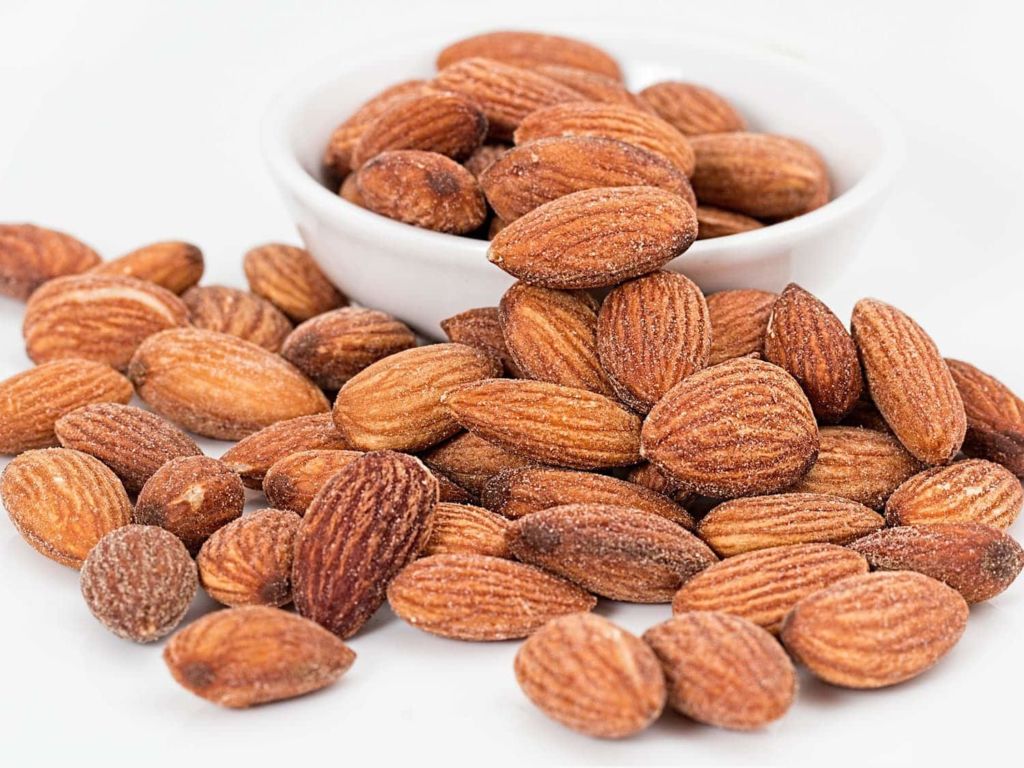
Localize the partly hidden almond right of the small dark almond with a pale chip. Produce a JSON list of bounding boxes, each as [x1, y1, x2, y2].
[[220, 414, 351, 490]]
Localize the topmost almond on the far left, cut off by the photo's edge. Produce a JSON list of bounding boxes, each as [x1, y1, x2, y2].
[[0, 224, 99, 299]]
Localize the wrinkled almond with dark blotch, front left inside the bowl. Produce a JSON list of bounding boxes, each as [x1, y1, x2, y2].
[[355, 150, 487, 234]]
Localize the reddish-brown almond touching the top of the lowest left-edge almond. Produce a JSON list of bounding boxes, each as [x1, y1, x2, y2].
[[54, 402, 203, 495]]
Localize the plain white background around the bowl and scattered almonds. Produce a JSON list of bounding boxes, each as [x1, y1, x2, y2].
[[0, 0, 1024, 767]]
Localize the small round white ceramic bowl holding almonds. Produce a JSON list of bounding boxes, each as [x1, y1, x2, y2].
[[263, 34, 902, 338]]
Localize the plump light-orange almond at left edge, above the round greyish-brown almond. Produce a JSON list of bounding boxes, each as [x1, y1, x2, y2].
[[0, 449, 131, 568]]
